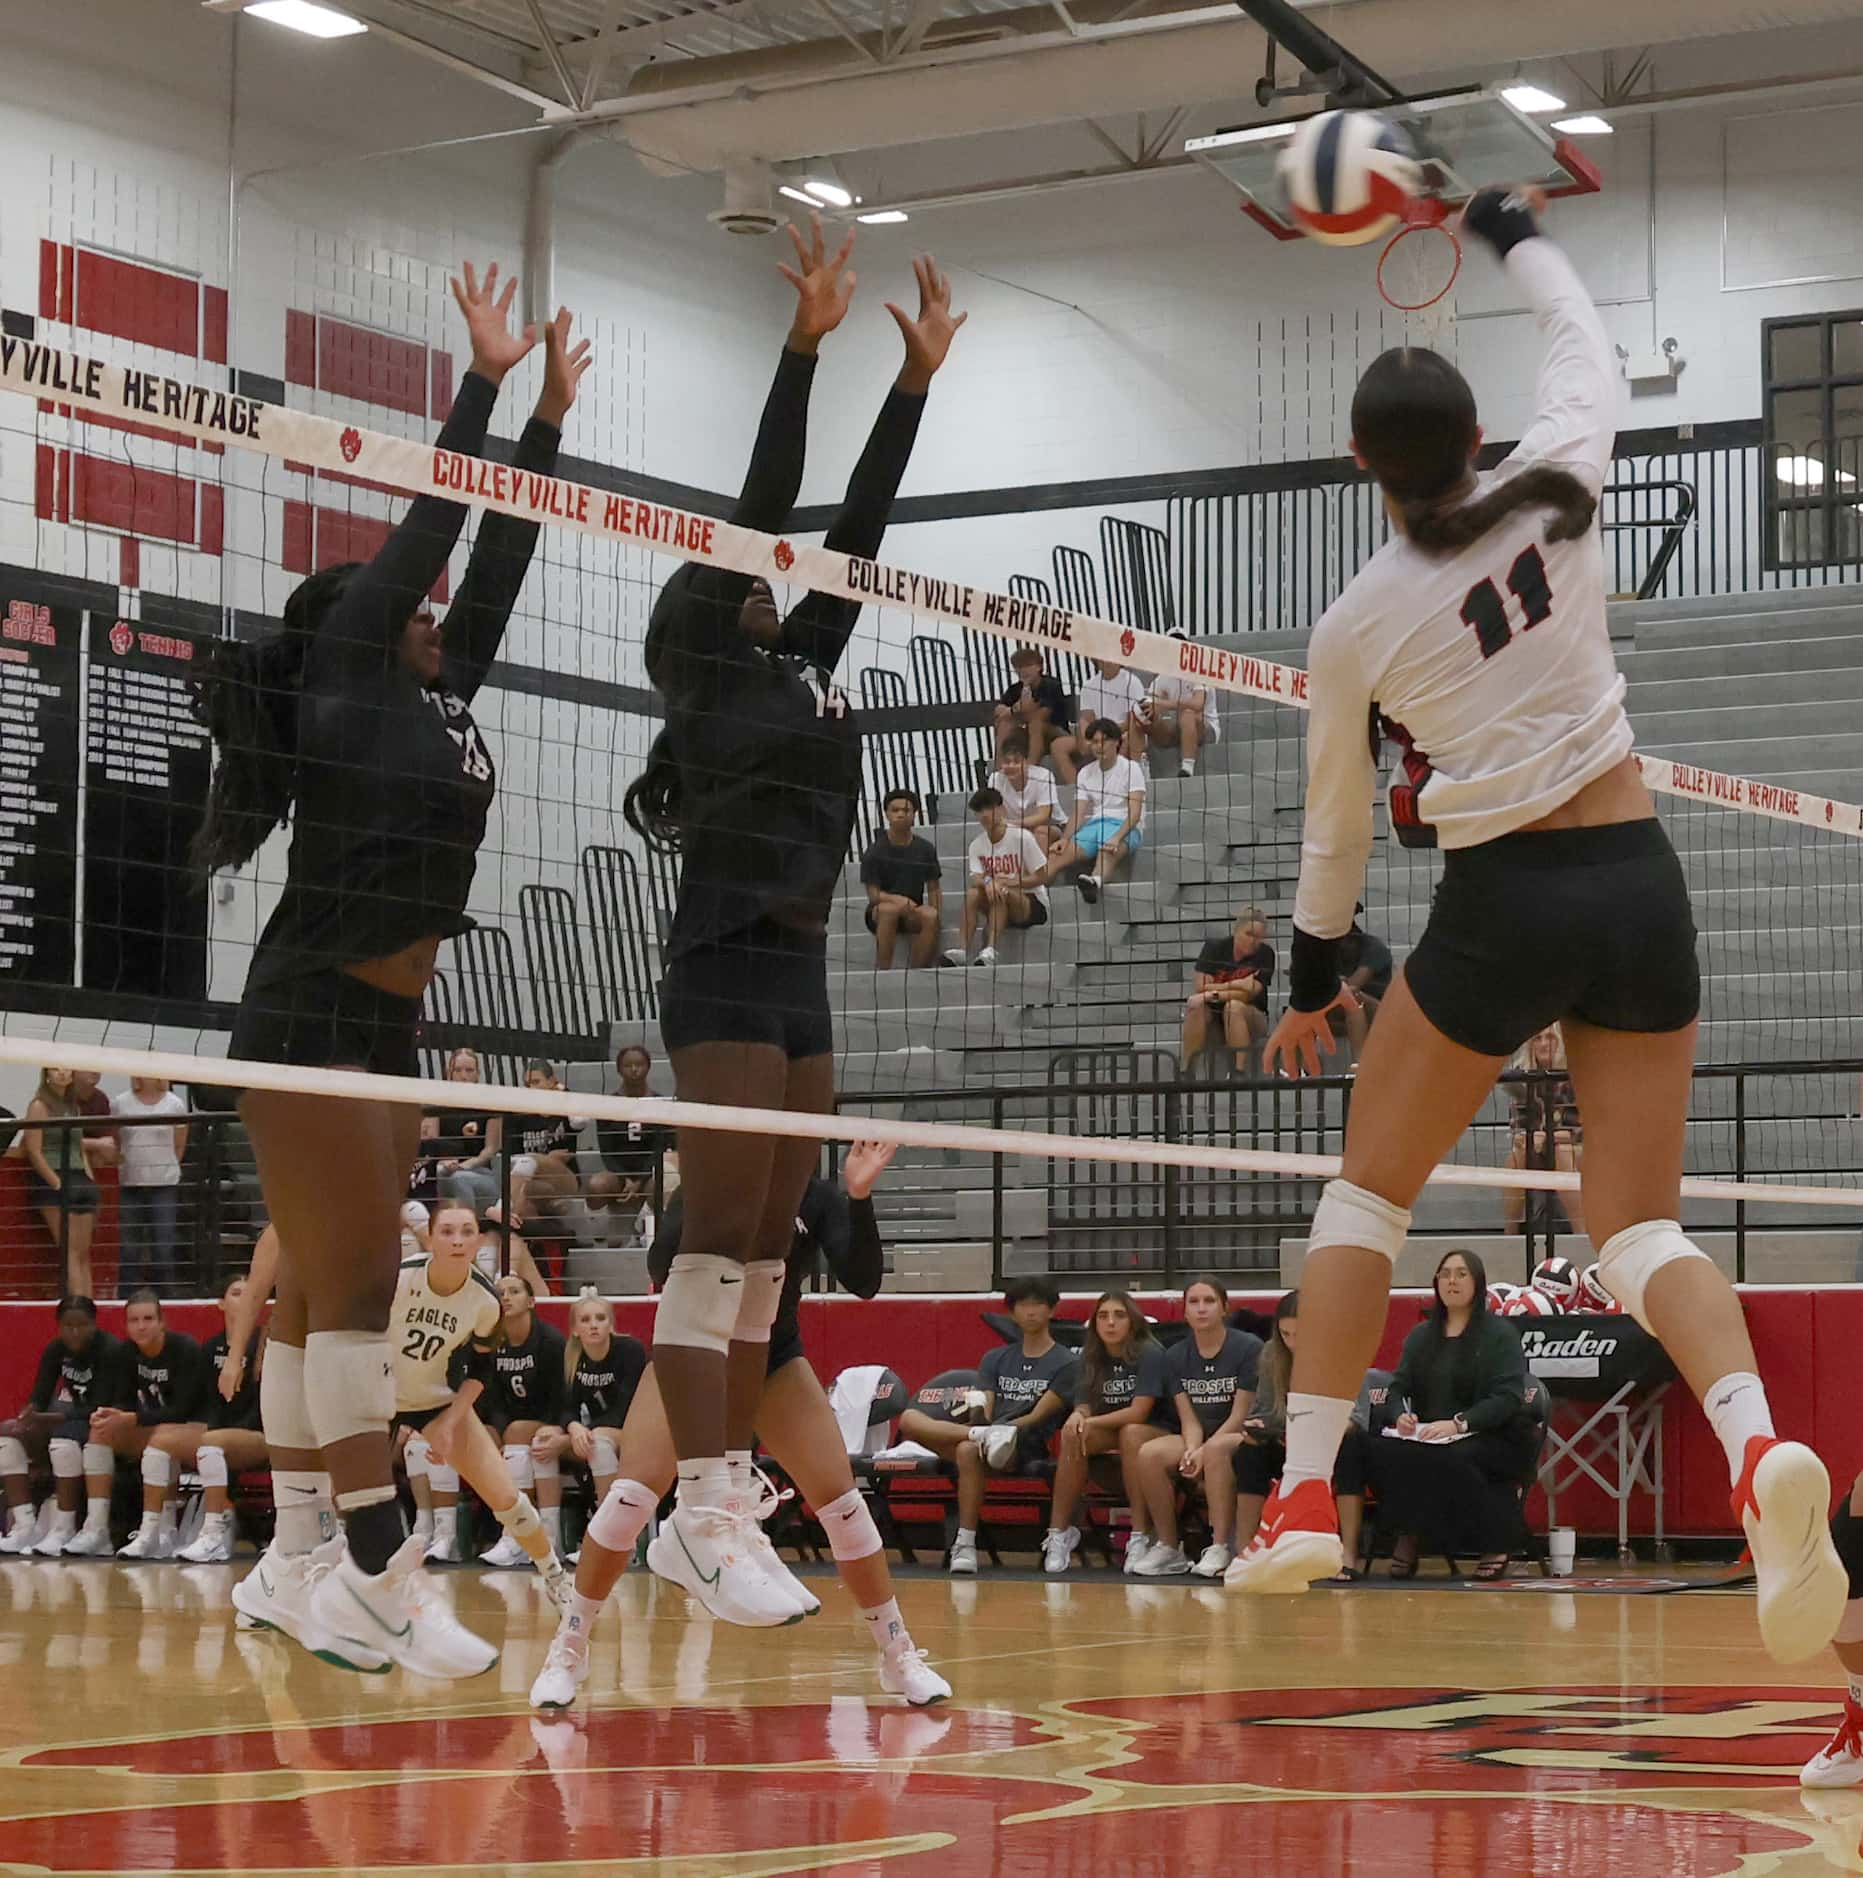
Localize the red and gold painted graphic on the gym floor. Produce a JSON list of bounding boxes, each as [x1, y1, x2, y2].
[[0, 1686, 1863, 1878]]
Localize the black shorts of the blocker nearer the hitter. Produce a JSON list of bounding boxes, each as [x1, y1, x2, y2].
[[659, 920, 834, 1061]]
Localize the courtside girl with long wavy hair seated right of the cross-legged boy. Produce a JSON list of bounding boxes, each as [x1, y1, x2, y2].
[[1042, 1290, 1170, 1574]]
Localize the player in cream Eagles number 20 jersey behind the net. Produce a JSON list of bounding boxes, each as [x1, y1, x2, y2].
[[389, 1200, 565, 1615]]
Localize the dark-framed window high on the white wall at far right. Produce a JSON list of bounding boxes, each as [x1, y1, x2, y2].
[[1760, 310, 1863, 567]]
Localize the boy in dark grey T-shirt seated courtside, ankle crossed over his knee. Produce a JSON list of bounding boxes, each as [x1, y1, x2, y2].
[[900, 1277, 1076, 1578]]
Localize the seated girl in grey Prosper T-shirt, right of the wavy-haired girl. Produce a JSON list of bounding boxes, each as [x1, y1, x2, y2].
[[1125, 1279, 1262, 1578]]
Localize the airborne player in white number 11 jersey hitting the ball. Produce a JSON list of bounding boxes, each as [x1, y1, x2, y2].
[[1226, 190, 1846, 1662]]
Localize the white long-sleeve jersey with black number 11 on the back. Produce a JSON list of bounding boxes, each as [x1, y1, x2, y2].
[[1294, 237, 1630, 939]]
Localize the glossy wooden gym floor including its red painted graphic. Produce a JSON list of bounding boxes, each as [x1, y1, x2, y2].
[[0, 1561, 1863, 1878]]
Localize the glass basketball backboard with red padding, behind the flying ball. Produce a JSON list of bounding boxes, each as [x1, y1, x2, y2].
[[1183, 90, 1602, 240]]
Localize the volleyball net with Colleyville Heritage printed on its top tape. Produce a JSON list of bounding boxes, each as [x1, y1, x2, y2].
[[0, 307, 1863, 1294]]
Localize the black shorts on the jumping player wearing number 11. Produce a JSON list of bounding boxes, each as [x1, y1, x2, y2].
[[1403, 819, 1701, 1055]]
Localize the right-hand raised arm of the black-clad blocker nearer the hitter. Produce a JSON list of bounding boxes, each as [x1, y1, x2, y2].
[[783, 255, 971, 670]]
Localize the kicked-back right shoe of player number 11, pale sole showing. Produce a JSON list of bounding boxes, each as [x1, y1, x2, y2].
[[1733, 1435, 1850, 1664]]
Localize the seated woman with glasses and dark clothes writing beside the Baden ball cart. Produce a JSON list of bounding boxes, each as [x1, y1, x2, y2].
[[1363, 1251, 1540, 1579]]
